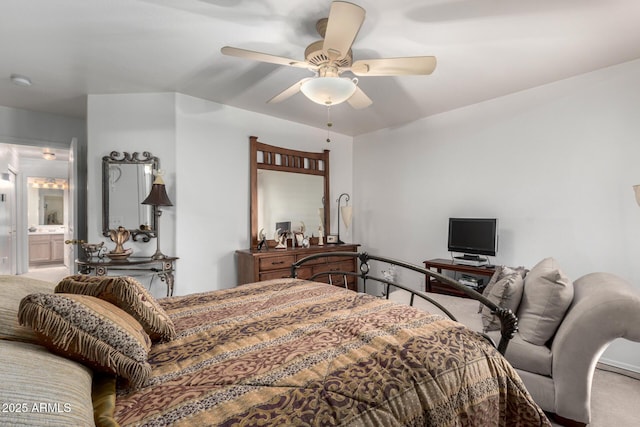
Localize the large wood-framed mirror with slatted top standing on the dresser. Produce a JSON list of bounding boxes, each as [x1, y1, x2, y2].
[[249, 136, 331, 247]]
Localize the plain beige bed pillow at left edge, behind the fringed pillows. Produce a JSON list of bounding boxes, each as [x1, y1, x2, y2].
[[0, 276, 56, 344]]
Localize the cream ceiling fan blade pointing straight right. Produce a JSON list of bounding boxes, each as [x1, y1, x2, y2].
[[351, 56, 436, 76]]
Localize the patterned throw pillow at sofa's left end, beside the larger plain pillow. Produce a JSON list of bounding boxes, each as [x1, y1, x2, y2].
[[481, 266, 524, 332]]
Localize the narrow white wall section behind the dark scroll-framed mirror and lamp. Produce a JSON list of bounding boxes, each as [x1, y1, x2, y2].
[[87, 93, 176, 270]]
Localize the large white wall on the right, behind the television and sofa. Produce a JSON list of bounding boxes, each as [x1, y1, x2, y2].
[[353, 61, 640, 372]]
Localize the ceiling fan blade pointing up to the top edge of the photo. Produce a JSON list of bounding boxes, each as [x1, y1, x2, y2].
[[323, 1, 365, 59]]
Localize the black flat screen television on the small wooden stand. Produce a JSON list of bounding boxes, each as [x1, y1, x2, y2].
[[448, 218, 498, 256]]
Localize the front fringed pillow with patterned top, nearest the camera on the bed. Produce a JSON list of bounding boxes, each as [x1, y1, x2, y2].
[[18, 293, 151, 387]]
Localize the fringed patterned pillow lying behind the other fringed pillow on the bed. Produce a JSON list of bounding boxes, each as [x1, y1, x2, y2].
[[56, 274, 176, 341]]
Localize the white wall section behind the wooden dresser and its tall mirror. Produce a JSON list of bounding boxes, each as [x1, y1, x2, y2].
[[176, 95, 352, 294]]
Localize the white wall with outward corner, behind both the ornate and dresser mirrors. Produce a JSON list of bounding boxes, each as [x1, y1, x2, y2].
[[87, 93, 352, 296]]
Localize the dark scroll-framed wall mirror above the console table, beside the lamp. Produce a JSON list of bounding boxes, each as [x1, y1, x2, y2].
[[102, 151, 160, 242]]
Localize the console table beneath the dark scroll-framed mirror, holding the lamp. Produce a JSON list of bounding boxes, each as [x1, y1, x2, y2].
[[76, 256, 178, 297]]
